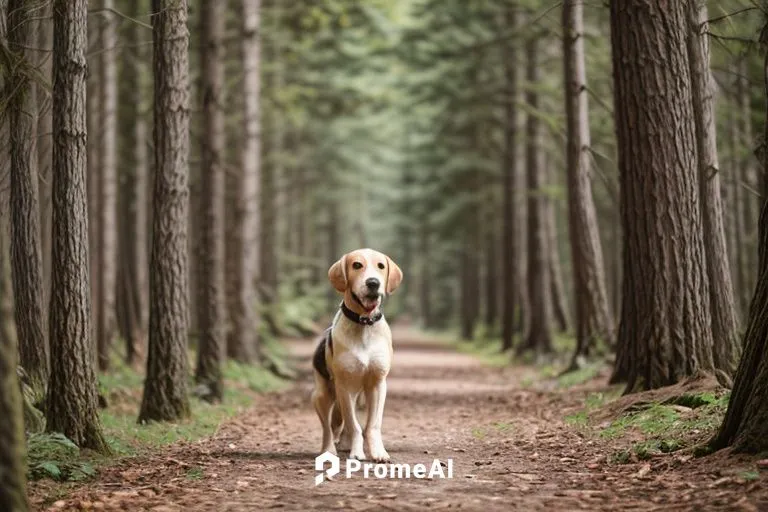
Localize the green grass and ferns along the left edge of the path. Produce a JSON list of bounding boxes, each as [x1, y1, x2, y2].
[[28, 352, 286, 481]]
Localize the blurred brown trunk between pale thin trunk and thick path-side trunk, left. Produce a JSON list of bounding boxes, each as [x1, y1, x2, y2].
[[119, 1, 149, 365]]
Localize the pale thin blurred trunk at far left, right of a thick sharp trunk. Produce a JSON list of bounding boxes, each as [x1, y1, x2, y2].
[[96, 0, 117, 370]]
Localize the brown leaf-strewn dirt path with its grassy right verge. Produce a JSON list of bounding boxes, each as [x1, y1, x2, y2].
[[30, 329, 768, 512]]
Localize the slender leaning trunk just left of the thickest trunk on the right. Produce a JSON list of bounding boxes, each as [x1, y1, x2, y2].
[[563, 0, 614, 369]]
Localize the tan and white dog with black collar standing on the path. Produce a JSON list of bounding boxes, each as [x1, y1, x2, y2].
[[312, 249, 403, 462]]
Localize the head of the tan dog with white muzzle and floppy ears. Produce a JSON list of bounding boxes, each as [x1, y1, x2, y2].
[[328, 249, 403, 314]]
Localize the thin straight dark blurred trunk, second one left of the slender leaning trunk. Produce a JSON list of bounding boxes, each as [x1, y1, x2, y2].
[[501, 7, 521, 351]]
